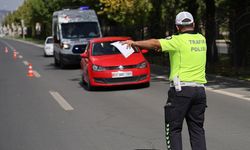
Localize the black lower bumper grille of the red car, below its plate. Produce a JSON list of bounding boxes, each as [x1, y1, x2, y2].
[[94, 75, 147, 84]]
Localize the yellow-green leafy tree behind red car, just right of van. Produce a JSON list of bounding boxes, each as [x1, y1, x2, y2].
[[98, 0, 151, 38]]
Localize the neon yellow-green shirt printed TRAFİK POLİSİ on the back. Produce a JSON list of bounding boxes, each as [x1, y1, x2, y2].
[[159, 33, 207, 83]]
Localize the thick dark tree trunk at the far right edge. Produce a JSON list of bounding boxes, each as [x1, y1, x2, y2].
[[228, 0, 250, 68]]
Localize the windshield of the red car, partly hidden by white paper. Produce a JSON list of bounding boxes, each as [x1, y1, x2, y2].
[[92, 41, 139, 56]]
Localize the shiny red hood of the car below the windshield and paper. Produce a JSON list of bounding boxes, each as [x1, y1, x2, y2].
[[91, 53, 145, 67]]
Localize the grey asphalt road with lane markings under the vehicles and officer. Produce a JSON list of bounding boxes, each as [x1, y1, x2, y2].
[[0, 39, 250, 150]]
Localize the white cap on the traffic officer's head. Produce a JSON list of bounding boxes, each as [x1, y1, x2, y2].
[[175, 11, 194, 25]]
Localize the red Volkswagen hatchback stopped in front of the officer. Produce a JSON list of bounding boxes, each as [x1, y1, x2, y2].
[[81, 37, 150, 90]]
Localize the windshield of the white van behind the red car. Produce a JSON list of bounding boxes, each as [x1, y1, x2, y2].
[[62, 22, 100, 39]]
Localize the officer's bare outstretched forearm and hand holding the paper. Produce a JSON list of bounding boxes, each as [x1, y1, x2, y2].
[[122, 39, 161, 50]]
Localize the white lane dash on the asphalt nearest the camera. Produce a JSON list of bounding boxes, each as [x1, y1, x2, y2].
[[49, 91, 74, 111]]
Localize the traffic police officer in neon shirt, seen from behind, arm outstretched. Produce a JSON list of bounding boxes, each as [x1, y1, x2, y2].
[[123, 11, 207, 150]]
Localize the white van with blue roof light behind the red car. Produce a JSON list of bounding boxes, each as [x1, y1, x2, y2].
[[52, 7, 102, 68]]
